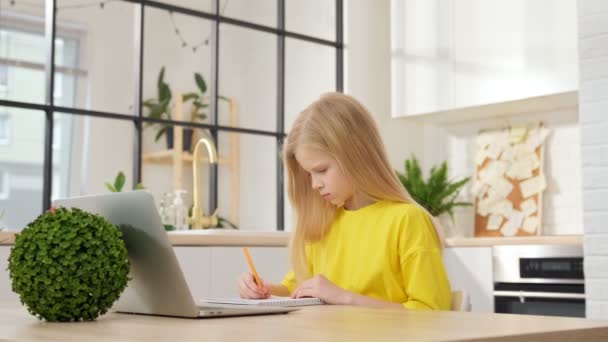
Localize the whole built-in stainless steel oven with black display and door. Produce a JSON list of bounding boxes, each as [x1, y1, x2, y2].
[[493, 245, 585, 317]]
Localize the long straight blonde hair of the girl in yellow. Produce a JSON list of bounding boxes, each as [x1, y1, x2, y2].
[[283, 93, 444, 282]]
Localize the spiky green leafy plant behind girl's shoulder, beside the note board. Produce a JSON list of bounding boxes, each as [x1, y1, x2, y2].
[[397, 155, 472, 220]]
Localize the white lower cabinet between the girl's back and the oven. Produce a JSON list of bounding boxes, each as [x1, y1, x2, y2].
[[443, 247, 494, 313]]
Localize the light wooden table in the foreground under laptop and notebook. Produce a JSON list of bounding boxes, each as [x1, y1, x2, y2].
[[0, 305, 608, 342]]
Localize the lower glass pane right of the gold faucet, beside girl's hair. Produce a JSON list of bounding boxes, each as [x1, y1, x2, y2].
[[218, 132, 277, 231]]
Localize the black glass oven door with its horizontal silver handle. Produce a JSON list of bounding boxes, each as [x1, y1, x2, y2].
[[494, 284, 585, 317]]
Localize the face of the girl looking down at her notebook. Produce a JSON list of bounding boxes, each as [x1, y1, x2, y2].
[[295, 146, 354, 206]]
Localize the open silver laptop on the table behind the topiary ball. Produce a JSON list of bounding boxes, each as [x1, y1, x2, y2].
[[53, 190, 297, 318]]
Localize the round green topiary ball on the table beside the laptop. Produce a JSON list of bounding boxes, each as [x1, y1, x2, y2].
[[8, 208, 129, 322]]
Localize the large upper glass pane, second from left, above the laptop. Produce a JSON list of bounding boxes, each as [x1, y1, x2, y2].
[[54, 0, 139, 115]]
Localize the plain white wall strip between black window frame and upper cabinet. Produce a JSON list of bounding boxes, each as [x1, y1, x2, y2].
[[345, 0, 423, 170]]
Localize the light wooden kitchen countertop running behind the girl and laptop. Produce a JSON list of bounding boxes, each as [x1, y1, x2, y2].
[[0, 229, 583, 247]]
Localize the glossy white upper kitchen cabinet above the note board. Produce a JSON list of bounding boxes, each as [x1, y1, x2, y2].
[[391, 0, 578, 117]]
